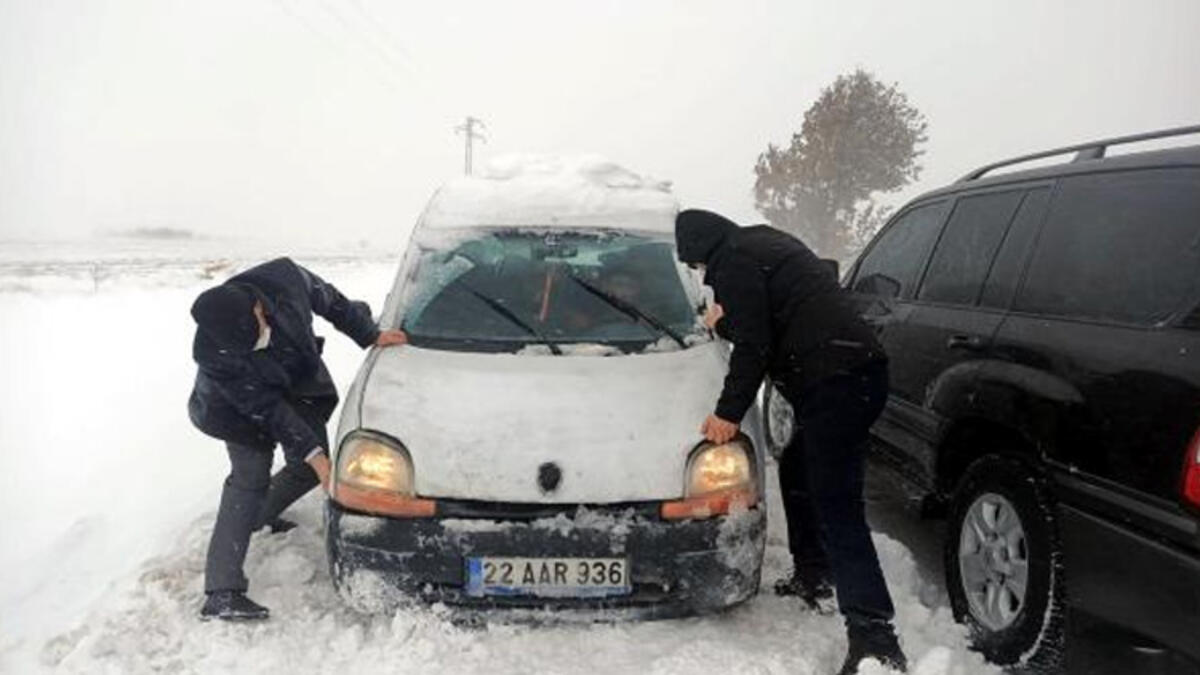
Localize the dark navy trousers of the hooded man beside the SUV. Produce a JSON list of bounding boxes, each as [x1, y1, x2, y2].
[[779, 362, 895, 623]]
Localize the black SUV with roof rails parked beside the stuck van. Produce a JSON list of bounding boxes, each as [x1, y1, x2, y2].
[[763, 127, 1200, 671]]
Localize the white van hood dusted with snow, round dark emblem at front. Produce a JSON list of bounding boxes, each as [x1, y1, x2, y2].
[[342, 342, 726, 503]]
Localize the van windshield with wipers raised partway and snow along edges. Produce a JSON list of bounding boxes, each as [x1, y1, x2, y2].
[[402, 228, 708, 354]]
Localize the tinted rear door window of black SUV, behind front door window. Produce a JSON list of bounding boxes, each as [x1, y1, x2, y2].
[[918, 190, 1022, 305]]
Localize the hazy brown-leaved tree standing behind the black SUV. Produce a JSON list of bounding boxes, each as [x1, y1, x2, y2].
[[755, 70, 928, 259]]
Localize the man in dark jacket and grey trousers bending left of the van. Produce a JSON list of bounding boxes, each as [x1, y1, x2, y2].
[[187, 258, 406, 620]]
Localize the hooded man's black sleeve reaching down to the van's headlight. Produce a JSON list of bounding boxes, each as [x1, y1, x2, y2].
[[713, 258, 772, 423]]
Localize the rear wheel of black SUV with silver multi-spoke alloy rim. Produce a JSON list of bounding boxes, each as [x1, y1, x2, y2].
[[944, 455, 1064, 671]]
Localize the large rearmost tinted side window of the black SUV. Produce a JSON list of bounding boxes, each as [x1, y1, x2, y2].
[[1016, 169, 1200, 324]]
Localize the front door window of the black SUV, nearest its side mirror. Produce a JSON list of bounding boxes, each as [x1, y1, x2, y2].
[[854, 202, 947, 298]]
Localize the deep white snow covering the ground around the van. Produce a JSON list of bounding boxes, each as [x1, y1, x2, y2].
[[0, 243, 997, 675]]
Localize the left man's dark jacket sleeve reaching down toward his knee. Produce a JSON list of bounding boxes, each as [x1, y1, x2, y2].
[[199, 356, 328, 460]]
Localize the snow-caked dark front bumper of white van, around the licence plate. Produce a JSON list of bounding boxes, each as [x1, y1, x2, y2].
[[325, 501, 766, 619]]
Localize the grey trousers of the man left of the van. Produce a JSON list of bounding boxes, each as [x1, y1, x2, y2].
[[204, 434, 324, 593]]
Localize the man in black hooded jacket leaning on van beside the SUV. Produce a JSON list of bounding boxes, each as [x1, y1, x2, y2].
[[676, 210, 905, 675]]
